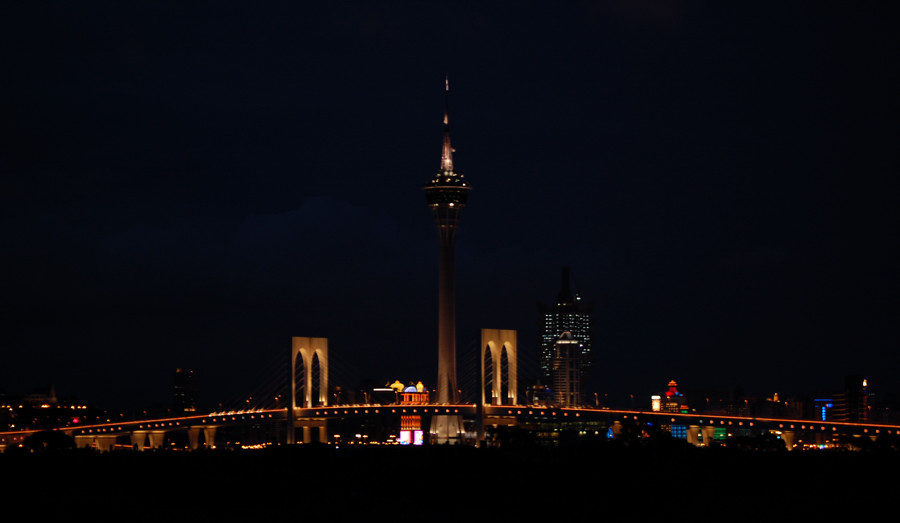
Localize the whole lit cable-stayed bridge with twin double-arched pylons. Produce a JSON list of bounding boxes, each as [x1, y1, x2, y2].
[[0, 329, 900, 451]]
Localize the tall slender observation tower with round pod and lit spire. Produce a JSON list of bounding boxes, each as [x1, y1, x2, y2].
[[424, 81, 470, 440]]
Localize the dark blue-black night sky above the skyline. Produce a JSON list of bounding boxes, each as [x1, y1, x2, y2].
[[0, 0, 900, 412]]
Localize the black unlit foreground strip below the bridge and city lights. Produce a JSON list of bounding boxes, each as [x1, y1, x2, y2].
[[0, 441, 900, 521]]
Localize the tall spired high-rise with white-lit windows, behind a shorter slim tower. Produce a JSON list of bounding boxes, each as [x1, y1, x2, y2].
[[538, 267, 593, 384]]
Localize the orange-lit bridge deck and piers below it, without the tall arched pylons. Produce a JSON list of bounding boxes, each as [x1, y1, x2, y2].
[[0, 404, 900, 451]]
